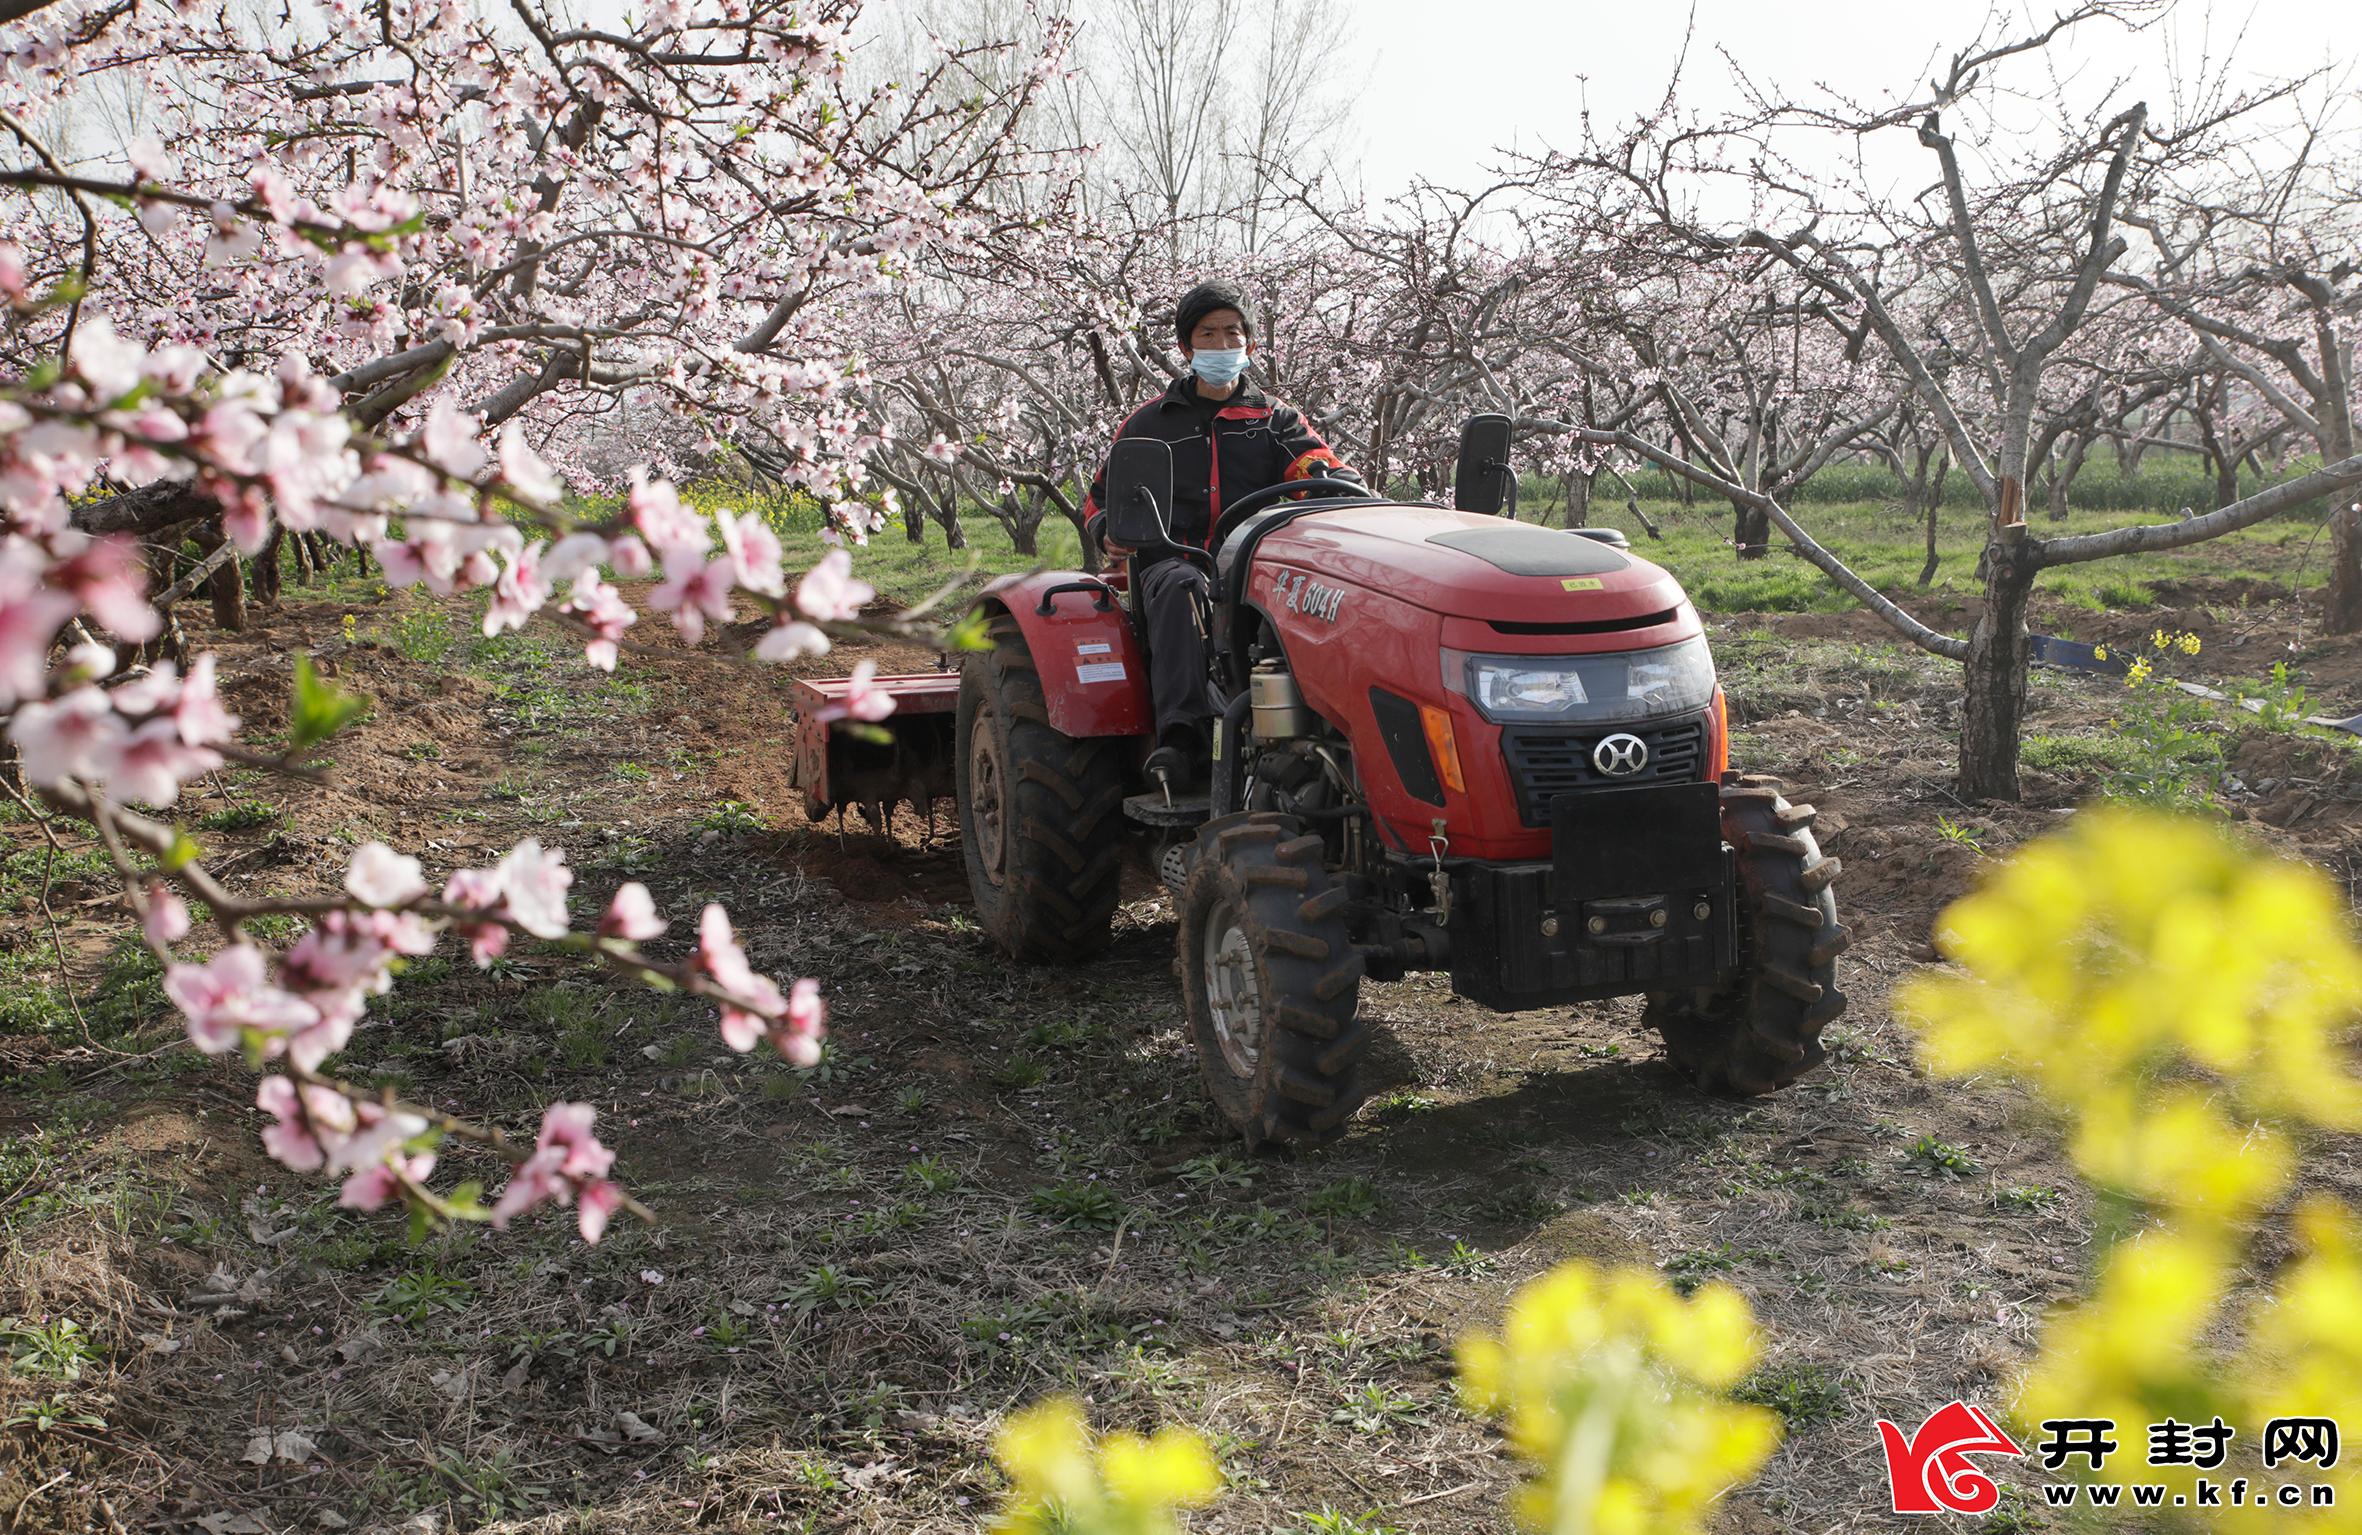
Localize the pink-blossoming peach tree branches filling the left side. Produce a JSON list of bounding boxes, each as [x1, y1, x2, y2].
[[0, 0, 1063, 1242]]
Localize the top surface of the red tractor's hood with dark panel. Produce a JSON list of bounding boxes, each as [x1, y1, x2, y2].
[[1247, 503, 1682, 628]]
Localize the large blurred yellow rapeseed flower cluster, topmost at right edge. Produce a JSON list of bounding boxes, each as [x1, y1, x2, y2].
[[1897, 808, 2362, 1219]]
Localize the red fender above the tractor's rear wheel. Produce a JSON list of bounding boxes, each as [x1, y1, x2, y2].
[[983, 571, 1155, 737]]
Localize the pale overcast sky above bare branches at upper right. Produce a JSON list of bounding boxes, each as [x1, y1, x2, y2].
[[1346, 0, 2362, 196]]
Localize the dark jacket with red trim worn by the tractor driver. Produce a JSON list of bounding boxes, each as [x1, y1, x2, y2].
[[1082, 373, 1361, 548]]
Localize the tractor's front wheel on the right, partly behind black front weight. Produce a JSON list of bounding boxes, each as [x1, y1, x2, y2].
[[1644, 777, 1849, 1098]]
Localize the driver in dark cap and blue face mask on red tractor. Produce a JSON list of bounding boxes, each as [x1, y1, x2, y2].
[[1084, 279, 1361, 789]]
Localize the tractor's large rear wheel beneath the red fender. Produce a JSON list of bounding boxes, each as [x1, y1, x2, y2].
[[957, 614, 1124, 961]]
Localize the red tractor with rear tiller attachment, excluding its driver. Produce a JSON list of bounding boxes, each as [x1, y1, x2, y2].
[[798, 416, 1845, 1145]]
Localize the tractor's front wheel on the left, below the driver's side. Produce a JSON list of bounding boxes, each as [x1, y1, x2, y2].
[[1176, 812, 1370, 1145]]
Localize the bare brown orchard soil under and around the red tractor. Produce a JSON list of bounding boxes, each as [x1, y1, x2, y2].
[[0, 576, 2362, 1535]]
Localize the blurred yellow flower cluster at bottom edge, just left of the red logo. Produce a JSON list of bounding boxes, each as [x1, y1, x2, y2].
[[1460, 1261, 1779, 1535]]
